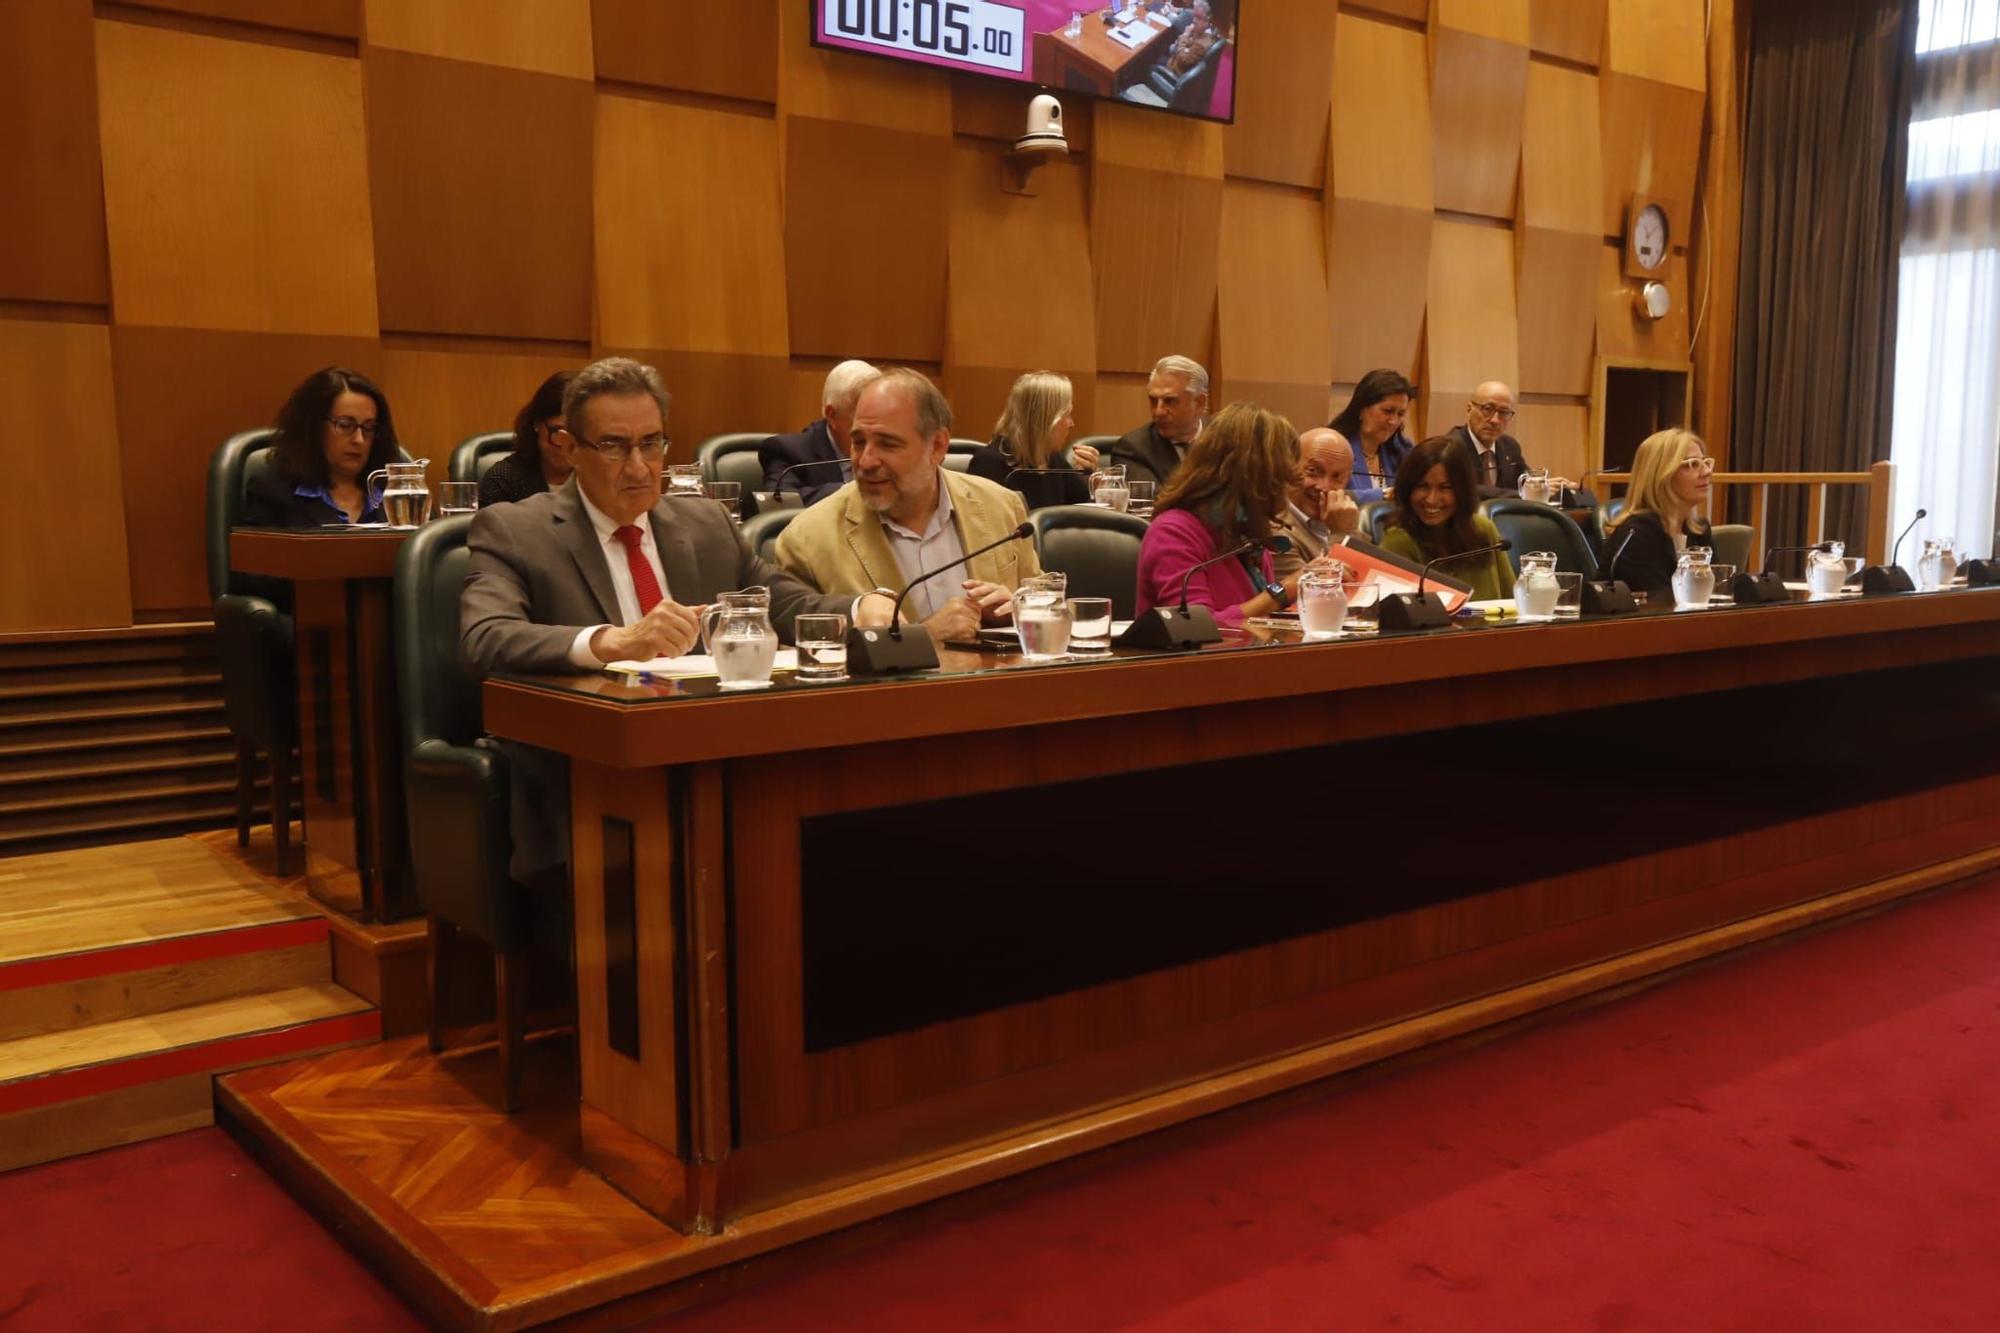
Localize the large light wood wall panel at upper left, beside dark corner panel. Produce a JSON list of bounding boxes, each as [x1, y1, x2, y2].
[[98, 20, 376, 336]]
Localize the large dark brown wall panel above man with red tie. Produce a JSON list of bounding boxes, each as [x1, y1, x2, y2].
[[362, 48, 592, 342]]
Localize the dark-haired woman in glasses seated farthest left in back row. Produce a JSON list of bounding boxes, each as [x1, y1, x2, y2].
[[242, 366, 398, 528]]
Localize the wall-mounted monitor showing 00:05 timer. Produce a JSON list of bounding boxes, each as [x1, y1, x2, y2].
[[808, 0, 1238, 120]]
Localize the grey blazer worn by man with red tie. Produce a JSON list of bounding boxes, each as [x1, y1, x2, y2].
[[458, 476, 854, 677]]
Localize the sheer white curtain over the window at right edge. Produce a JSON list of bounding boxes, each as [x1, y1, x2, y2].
[[1890, 0, 2000, 568]]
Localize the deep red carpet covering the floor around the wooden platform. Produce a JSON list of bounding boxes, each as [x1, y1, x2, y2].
[[0, 883, 2000, 1331]]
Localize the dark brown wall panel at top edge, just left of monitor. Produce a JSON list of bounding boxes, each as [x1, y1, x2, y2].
[[590, 0, 776, 102]]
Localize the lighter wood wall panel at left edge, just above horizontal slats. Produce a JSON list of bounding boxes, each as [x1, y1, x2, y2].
[[0, 320, 131, 632]]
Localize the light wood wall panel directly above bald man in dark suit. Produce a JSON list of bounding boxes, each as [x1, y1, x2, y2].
[[1422, 220, 1520, 394]]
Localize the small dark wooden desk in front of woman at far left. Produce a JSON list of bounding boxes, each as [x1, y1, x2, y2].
[[230, 528, 414, 921]]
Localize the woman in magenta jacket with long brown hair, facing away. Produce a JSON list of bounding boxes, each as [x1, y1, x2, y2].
[[1138, 402, 1298, 624]]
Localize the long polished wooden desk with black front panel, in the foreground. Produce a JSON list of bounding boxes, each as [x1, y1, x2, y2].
[[486, 592, 2000, 1232]]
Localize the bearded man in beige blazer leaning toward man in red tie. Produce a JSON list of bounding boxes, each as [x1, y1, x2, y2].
[[776, 366, 1042, 640]]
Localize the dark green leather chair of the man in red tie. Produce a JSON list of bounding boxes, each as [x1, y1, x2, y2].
[[394, 514, 570, 1111]]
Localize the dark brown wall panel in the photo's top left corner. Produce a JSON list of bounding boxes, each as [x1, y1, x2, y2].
[[0, 0, 110, 306]]
